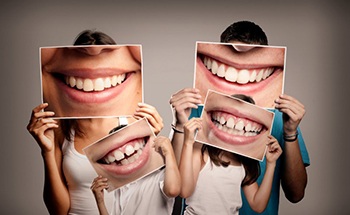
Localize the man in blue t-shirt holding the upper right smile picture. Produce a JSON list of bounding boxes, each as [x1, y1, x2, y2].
[[170, 21, 310, 215]]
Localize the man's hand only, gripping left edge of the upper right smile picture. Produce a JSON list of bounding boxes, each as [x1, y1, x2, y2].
[[169, 88, 202, 130]]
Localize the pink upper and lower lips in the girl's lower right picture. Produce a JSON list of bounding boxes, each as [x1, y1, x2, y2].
[[206, 110, 267, 145]]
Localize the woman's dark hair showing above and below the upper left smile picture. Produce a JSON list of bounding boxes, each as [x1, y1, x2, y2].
[[60, 30, 117, 141]]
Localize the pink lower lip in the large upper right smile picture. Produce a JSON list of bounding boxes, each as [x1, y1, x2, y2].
[[197, 56, 282, 95]]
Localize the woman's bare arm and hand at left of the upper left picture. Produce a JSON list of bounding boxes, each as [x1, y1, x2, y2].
[[27, 103, 70, 214]]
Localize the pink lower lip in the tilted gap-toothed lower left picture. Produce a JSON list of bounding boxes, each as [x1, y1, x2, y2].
[[100, 139, 150, 176]]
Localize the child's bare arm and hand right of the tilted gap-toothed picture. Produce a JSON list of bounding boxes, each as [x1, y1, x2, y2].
[[154, 136, 181, 197]]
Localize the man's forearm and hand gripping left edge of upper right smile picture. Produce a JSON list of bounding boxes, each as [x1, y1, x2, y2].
[[169, 88, 202, 163]]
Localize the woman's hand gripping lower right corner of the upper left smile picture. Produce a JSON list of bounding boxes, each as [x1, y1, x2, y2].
[[134, 103, 164, 135]]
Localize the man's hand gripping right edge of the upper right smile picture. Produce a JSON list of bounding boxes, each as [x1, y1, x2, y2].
[[275, 95, 305, 135]]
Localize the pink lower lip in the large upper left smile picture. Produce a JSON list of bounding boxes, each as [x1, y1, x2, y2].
[[58, 73, 135, 104]]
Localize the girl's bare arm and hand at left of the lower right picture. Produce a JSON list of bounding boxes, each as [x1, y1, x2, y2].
[[179, 118, 202, 198]]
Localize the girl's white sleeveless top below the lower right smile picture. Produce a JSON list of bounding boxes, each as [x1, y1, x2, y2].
[[185, 157, 245, 215]]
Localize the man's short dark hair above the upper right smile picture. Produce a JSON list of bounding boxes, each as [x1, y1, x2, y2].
[[220, 21, 268, 45]]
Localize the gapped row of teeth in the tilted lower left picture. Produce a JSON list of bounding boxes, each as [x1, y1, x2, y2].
[[104, 139, 144, 164]]
